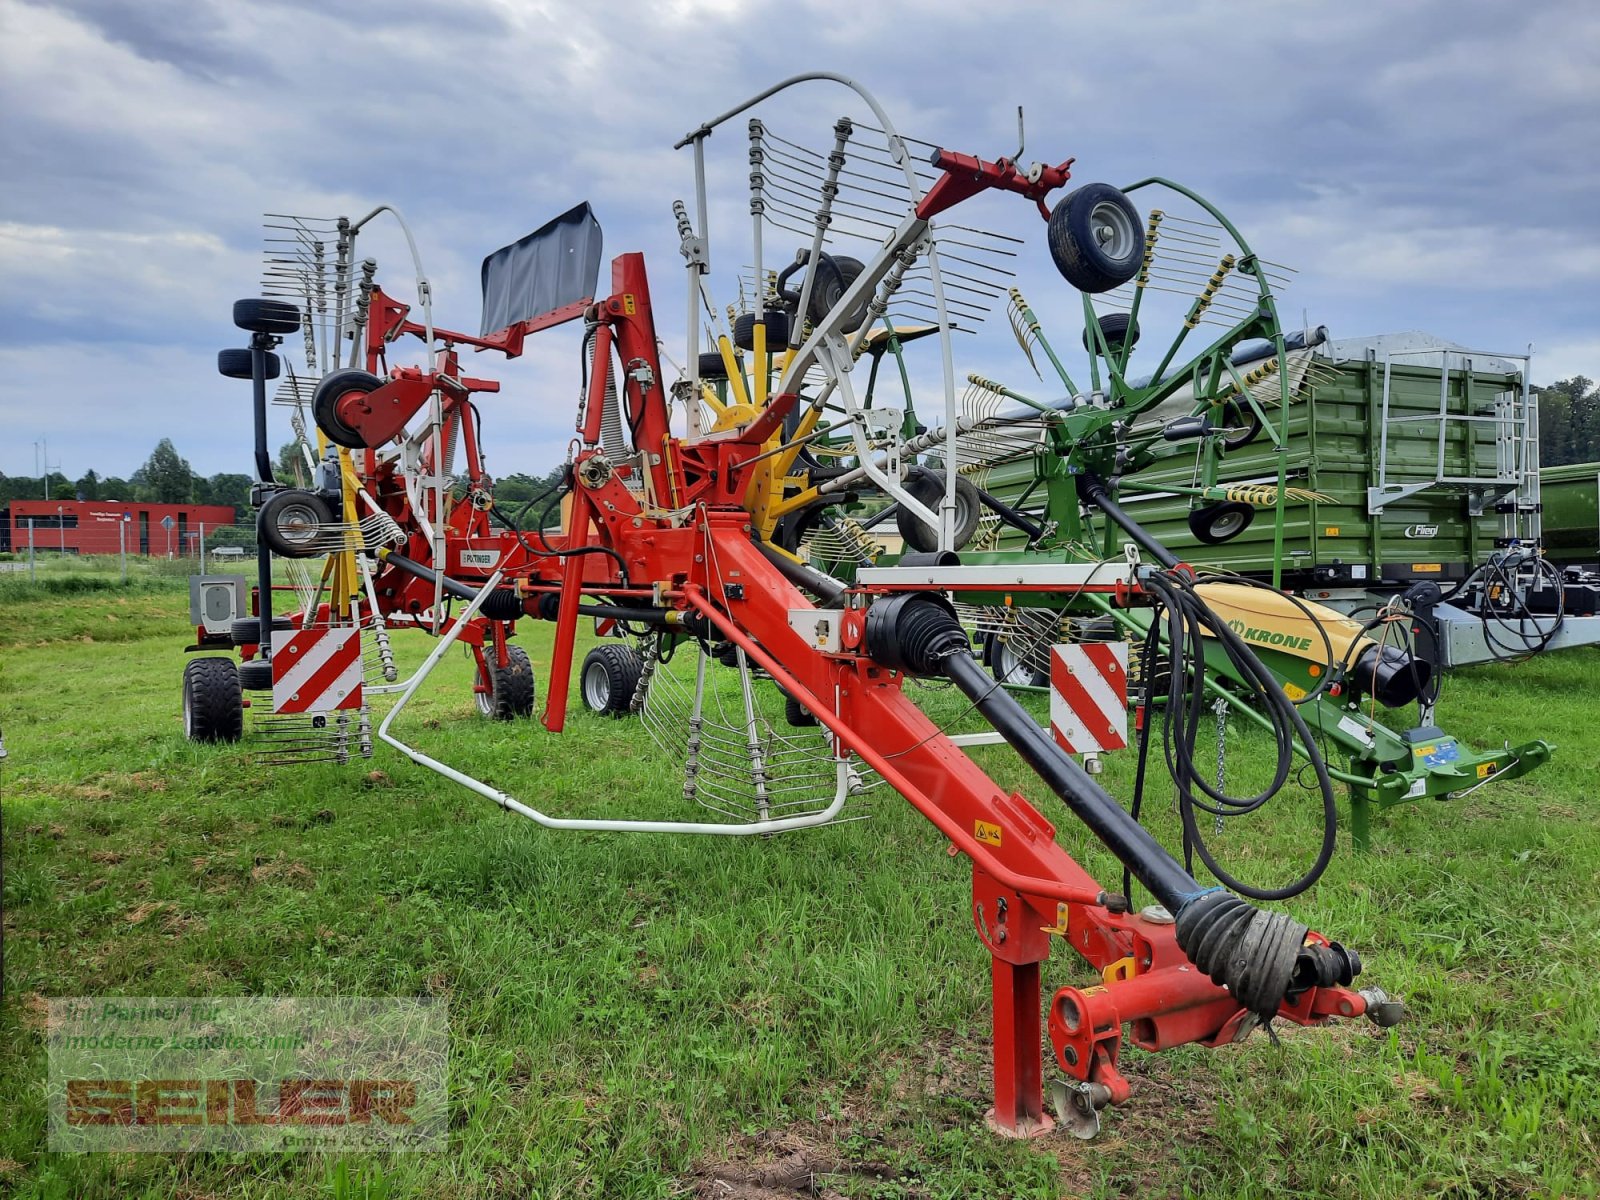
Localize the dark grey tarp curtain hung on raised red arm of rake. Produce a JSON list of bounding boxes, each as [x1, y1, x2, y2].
[[478, 202, 600, 338]]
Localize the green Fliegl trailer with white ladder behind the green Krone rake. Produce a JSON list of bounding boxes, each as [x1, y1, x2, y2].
[[984, 331, 1539, 606]]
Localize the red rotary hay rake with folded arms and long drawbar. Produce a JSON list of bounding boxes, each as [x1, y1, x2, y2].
[[216, 75, 1400, 1136]]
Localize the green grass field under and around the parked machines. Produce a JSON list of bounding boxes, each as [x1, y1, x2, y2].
[[0, 563, 1600, 1200]]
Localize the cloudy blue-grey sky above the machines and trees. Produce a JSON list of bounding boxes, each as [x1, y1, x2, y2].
[[0, 0, 1600, 478]]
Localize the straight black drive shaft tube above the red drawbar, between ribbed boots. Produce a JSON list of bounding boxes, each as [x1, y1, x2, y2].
[[939, 653, 1206, 912]]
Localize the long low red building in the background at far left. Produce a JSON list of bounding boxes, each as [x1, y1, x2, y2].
[[0, 499, 234, 557]]
